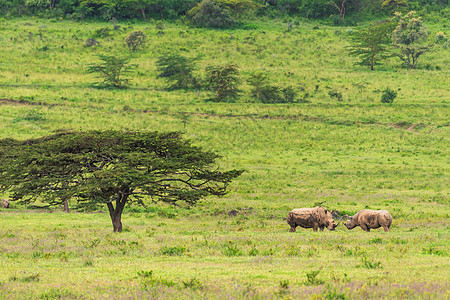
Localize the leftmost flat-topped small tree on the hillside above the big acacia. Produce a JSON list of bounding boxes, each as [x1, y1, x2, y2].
[[87, 55, 137, 88]]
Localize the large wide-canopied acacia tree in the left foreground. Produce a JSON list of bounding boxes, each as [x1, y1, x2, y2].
[[0, 131, 242, 232]]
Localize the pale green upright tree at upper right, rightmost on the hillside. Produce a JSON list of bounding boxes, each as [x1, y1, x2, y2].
[[392, 11, 430, 69]]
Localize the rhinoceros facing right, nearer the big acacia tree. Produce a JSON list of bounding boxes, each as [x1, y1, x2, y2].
[[287, 207, 338, 232]]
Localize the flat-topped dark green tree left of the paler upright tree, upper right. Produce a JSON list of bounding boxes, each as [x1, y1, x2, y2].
[[349, 21, 395, 70]]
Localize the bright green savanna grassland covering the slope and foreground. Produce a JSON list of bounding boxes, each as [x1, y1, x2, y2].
[[0, 18, 450, 299]]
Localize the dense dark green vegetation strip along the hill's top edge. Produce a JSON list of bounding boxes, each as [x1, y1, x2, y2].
[[0, 0, 449, 24]]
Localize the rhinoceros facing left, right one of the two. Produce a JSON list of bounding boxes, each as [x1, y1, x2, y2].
[[344, 209, 392, 232]]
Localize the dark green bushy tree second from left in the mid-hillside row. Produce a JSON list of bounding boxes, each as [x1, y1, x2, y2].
[[156, 54, 198, 90]]
